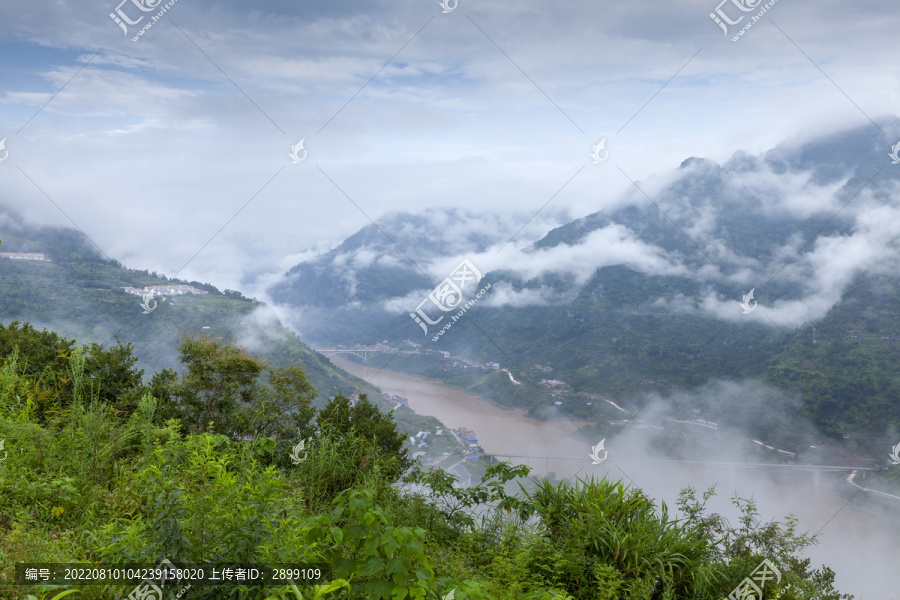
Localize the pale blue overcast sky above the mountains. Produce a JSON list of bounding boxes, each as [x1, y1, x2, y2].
[[0, 0, 900, 302]]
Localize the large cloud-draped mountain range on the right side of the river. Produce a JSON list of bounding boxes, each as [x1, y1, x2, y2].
[[273, 119, 900, 452]]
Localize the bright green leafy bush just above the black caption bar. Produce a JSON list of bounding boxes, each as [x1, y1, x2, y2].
[[98, 433, 320, 598]]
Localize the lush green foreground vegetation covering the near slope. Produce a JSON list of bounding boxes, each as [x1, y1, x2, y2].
[[0, 324, 850, 600]]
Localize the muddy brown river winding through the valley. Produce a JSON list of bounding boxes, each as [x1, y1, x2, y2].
[[331, 356, 900, 600]]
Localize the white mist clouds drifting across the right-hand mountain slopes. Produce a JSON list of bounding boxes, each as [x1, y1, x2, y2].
[[298, 145, 900, 336]]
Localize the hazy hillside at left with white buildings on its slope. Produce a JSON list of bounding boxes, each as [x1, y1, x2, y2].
[[0, 212, 377, 403]]
